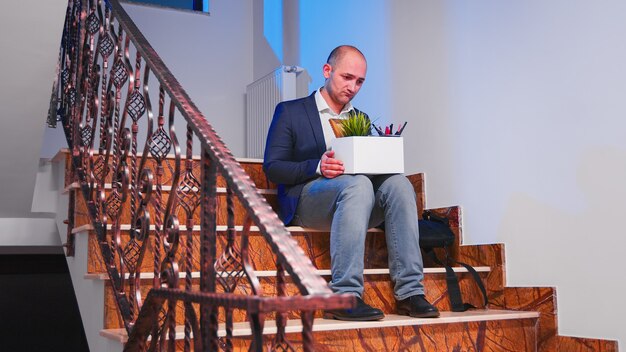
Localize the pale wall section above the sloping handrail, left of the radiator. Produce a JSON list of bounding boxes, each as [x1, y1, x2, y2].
[[124, 0, 253, 156]]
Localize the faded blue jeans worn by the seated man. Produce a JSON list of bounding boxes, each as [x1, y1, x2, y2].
[[294, 174, 424, 300]]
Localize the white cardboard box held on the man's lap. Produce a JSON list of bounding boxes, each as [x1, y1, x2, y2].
[[331, 136, 404, 175]]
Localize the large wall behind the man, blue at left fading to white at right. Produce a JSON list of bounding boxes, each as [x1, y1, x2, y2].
[[255, 0, 626, 341]]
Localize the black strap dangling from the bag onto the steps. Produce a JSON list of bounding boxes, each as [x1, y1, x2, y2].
[[426, 249, 489, 312]]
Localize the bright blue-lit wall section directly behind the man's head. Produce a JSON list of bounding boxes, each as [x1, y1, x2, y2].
[[300, 0, 394, 123]]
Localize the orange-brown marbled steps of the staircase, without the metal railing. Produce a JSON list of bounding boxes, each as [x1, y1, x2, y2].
[[48, 151, 617, 351]]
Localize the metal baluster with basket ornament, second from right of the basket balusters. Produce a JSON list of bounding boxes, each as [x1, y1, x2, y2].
[[176, 125, 201, 351]]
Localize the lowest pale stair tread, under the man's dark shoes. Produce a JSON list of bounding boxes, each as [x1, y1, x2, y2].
[[100, 309, 539, 343]]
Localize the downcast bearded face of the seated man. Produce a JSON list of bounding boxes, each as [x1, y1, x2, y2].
[[323, 51, 367, 110]]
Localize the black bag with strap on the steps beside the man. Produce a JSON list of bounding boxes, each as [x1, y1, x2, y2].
[[419, 210, 489, 312]]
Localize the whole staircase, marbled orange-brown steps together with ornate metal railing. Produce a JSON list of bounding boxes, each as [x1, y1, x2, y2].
[[48, 0, 617, 351]]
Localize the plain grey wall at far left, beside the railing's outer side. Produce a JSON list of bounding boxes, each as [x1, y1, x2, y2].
[[0, 0, 67, 218]]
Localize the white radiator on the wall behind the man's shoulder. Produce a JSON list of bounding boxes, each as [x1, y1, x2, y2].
[[246, 66, 311, 158]]
